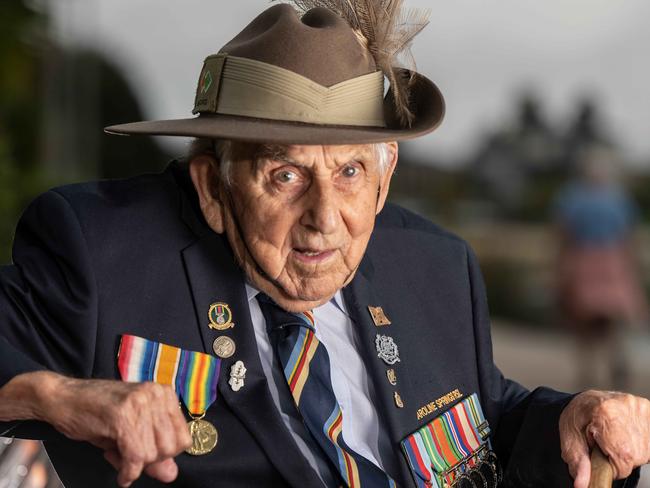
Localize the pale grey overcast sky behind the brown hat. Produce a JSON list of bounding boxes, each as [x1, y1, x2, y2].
[[51, 0, 650, 166]]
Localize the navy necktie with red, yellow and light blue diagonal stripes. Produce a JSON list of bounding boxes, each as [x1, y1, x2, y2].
[[257, 293, 395, 488]]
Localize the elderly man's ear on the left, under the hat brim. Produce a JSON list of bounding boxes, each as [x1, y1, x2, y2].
[[190, 154, 224, 234]]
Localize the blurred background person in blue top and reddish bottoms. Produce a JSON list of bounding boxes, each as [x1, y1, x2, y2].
[[553, 147, 647, 390]]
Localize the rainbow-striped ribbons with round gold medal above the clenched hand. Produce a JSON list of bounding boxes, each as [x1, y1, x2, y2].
[[117, 334, 221, 456]]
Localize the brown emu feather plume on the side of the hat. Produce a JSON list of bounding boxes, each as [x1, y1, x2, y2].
[[276, 0, 429, 127]]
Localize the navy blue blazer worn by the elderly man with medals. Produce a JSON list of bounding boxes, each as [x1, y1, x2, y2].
[[0, 163, 632, 488]]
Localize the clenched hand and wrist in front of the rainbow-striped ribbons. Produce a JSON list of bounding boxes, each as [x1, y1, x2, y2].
[[0, 371, 192, 486]]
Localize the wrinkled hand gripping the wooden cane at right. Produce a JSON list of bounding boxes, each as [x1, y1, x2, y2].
[[560, 390, 650, 488]]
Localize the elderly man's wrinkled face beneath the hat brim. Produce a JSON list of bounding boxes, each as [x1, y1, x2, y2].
[[208, 143, 397, 311]]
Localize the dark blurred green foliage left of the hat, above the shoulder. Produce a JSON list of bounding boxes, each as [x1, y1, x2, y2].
[[0, 1, 167, 263]]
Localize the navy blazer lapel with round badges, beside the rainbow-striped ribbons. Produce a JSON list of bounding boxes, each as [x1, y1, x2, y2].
[[182, 232, 320, 486]]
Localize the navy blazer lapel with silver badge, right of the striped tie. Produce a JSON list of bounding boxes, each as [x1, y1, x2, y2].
[[343, 255, 413, 486]]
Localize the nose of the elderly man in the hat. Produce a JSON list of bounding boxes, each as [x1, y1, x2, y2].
[[300, 180, 342, 234]]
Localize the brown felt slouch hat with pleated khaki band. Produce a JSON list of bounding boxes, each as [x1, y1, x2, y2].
[[105, 4, 444, 144]]
